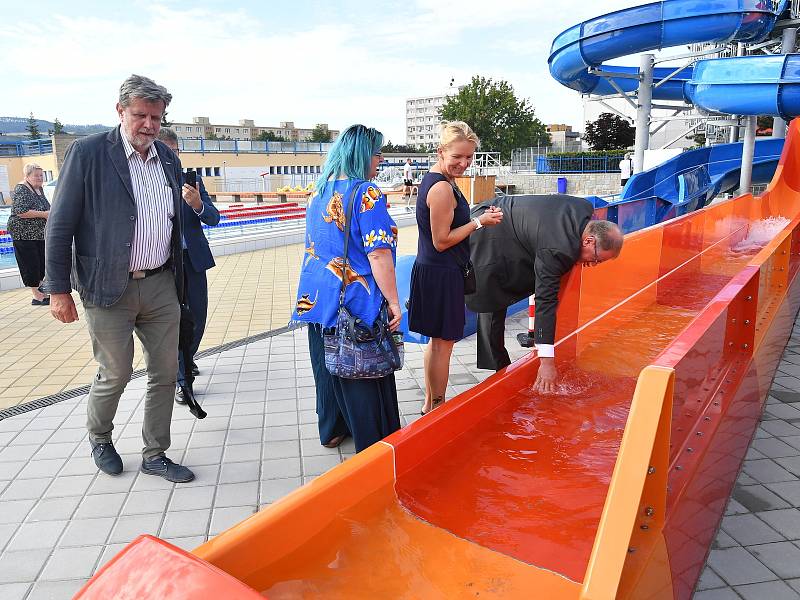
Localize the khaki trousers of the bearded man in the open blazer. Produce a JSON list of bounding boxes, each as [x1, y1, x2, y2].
[[83, 270, 180, 459]]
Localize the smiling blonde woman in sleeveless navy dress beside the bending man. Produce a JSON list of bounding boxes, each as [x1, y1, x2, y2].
[[408, 121, 503, 415]]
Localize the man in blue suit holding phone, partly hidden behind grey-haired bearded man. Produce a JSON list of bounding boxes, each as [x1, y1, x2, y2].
[[158, 127, 219, 404]]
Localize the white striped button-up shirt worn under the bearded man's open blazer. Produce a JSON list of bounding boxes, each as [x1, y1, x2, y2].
[[120, 131, 175, 271]]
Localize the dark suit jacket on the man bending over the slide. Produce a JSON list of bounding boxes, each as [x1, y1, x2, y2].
[[466, 194, 593, 344]]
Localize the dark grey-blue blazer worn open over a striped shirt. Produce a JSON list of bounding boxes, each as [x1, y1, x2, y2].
[[42, 127, 183, 307]]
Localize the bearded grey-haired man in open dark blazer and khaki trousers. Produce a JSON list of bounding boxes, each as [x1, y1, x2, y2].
[[42, 75, 194, 483]]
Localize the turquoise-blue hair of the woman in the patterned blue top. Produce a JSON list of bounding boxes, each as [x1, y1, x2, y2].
[[316, 125, 383, 196]]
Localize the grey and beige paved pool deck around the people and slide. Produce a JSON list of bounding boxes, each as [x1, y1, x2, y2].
[[0, 228, 800, 600]]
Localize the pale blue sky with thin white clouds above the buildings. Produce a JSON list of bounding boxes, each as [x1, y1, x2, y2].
[[0, 0, 641, 143]]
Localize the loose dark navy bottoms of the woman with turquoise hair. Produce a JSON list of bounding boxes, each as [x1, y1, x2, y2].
[[308, 323, 400, 452]]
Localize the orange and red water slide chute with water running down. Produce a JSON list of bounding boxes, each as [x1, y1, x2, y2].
[[77, 120, 800, 599]]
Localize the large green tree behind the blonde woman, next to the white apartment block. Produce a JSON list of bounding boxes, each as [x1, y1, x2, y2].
[[440, 75, 550, 160]]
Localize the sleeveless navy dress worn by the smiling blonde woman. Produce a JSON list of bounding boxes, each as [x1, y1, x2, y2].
[[408, 173, 470, 340]]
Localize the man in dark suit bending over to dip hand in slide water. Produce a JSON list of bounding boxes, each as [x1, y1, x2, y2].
[[466, 194, 623, 393]]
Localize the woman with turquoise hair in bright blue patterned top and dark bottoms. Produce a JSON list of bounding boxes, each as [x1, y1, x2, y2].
[[292, 125, 401, 452]]
